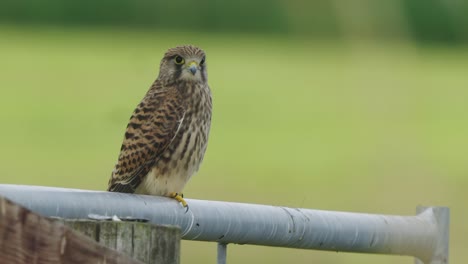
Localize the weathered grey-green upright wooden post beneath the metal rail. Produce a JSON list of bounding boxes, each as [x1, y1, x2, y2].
[[60, 219, 180, 264]]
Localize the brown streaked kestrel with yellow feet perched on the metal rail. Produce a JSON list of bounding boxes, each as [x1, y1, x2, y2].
[[108, 45, 212, 209]]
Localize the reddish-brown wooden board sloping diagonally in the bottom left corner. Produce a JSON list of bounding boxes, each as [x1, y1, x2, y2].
[[0, 197, 141, 264]]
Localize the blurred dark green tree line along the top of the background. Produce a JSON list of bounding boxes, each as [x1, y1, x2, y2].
[[0, 0, 468, 43]]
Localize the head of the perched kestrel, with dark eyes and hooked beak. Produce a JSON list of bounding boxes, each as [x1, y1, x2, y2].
[[158, 45, 207, 83]]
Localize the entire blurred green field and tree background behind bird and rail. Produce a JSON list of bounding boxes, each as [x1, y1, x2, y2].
[[0, 0, 468, 264]]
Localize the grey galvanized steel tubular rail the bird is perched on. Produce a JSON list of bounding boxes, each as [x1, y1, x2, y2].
[[0, 184, 449, 264]]
